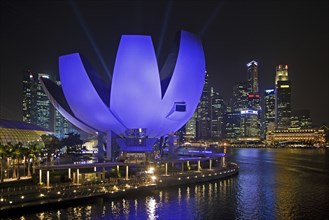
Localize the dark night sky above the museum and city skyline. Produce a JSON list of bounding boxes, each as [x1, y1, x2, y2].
[[0, 0, 329, 125]]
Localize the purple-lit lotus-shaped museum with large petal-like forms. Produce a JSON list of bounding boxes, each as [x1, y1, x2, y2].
[[41, 31, 205, 158]]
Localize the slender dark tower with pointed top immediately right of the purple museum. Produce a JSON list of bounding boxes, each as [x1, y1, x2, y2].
[[196, 73, 211, 139]]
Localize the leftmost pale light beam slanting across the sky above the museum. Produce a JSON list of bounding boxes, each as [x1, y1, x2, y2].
[[69, 0, 112, 80]]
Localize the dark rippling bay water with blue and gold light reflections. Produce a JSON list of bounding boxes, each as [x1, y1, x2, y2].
[[8, 149, 329, 220]]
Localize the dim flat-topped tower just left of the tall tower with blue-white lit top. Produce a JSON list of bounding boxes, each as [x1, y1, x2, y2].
[[232, 82, 248, 111]]
